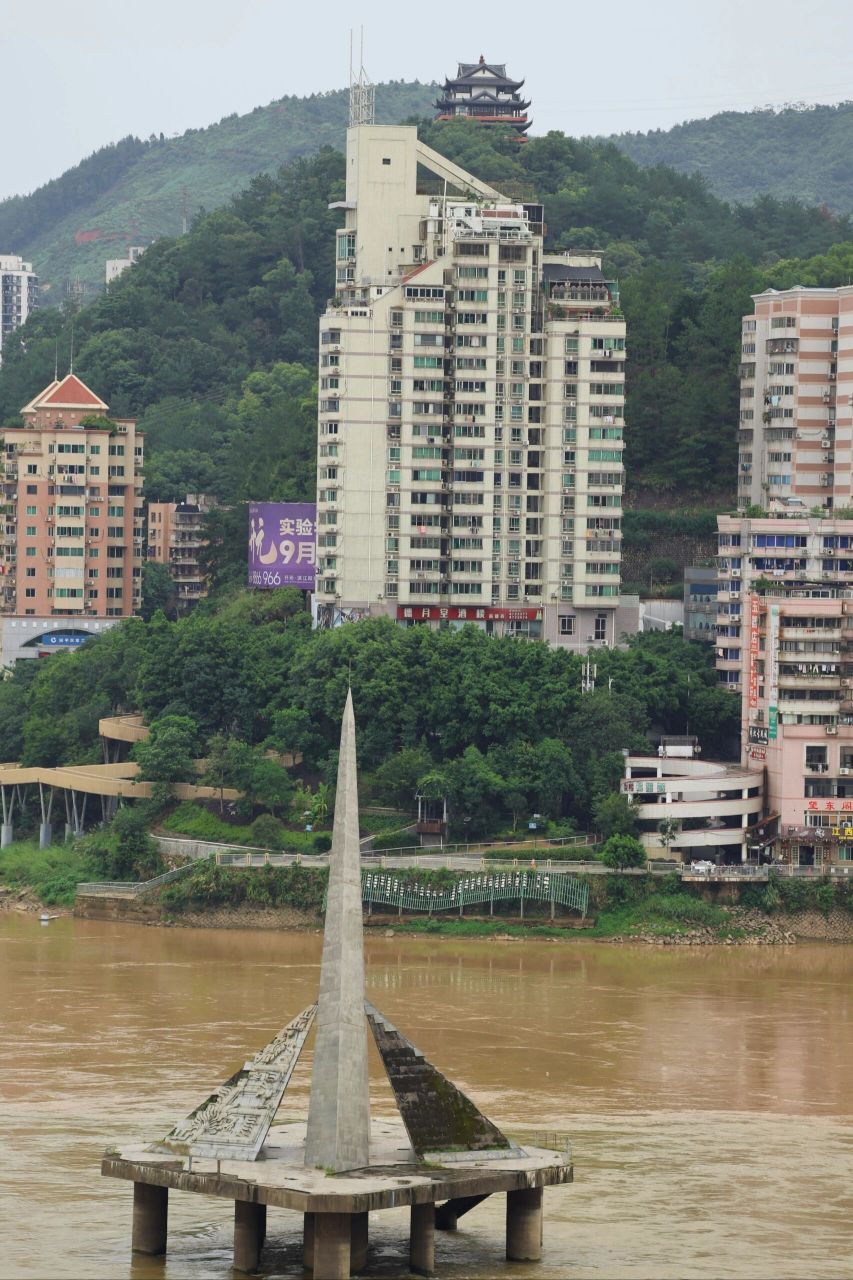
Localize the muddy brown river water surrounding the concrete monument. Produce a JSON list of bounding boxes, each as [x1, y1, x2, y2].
[[0, 914, 853, 1280]]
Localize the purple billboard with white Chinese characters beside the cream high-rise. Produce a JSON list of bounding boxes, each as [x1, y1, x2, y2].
[[248, 502, 316, 591]]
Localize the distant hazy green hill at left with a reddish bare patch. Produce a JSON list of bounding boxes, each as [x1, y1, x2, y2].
[[0, 81, 435, 302]]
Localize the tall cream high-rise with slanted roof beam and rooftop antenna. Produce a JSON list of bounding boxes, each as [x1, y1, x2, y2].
[[316, 125, 637, 648]]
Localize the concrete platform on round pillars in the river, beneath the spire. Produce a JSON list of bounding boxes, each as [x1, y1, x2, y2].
[[101, 1120, 573, 1280]]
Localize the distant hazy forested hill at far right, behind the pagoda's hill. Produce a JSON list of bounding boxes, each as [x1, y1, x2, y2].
[[611, 102, 853, 214]]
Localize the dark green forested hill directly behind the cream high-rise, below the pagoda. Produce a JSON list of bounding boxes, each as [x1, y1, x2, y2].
[[0, 120, 853, 504]]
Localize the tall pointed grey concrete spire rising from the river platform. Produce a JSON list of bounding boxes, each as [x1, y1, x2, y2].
[[305, 690, 370, 1172]]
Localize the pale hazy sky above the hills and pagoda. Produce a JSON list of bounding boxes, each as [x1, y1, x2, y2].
[[0, 0, 853, 200]]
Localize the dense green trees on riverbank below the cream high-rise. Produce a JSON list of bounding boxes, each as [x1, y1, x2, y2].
[[0, 590, 738, 845]]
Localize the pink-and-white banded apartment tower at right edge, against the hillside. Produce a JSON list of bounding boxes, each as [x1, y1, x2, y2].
[[738, 285, 853, 511]]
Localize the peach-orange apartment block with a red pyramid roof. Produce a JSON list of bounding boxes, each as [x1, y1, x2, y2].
[[0, 374, 143, 618]]
